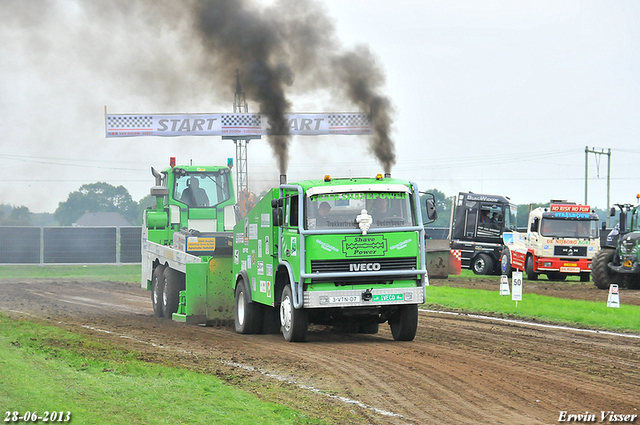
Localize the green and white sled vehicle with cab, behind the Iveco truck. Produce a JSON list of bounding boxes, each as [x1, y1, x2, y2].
[[141, 158, 236, 324]]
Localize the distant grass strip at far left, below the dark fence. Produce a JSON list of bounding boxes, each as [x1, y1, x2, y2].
[[0, 264, 141, 282]]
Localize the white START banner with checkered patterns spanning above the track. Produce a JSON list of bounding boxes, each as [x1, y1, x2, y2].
[[105, 113, 373, 137]]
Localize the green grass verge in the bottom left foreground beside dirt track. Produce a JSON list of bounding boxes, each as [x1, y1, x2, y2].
[[0, 314, 328, 424]]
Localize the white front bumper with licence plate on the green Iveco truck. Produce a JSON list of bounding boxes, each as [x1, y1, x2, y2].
[[304, 286, 426, 308]]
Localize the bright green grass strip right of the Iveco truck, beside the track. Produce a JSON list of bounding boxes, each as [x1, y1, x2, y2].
[[425, 286, 640, 332]]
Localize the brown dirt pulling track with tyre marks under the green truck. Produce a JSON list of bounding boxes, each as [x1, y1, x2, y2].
[[0, 280, 640, 424]]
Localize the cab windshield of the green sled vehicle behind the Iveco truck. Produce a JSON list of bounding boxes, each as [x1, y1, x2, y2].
[[173, 172, 231, 208]]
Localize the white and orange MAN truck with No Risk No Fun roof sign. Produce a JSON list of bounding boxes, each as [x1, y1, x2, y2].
[[501, 201, 600, 282]]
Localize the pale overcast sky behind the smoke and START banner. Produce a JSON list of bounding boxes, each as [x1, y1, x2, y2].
[[0, 0, 640, 212]]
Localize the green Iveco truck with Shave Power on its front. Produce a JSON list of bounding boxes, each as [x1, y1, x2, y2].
[[232, 175, 436, 341]]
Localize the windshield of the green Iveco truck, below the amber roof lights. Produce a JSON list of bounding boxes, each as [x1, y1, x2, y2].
[[305, 192, 415, 229]]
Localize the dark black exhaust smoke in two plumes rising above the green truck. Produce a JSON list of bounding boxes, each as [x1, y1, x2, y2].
[[195, 0, 396, 174]]
